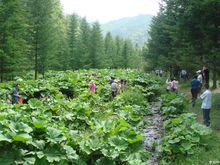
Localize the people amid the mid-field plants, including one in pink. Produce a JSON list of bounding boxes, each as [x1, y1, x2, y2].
[[89, 77, 127, 98]]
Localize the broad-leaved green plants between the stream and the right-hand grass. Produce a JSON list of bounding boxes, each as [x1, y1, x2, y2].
[[161, 93, 211, 162]]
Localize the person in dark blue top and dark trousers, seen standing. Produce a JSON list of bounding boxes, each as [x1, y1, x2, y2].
[[191, 76, 201, 107]]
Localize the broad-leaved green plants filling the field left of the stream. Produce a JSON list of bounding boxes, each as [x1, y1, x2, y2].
[[0, 70, 161, 165]]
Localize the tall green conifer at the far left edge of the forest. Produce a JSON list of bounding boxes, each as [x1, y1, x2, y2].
[[0, 0, 28, 81]]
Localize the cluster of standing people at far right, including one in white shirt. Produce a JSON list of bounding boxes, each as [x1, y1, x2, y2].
[[191, 67, 212, 126]]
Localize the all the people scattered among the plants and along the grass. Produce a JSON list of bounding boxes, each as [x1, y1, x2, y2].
[[6, 67, 211, 126]]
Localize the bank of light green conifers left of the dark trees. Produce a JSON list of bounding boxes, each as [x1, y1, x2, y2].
[[0, 0, 142, 81]]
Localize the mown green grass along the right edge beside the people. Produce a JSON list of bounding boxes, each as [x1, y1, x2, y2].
[[178, 82, 220, 165]]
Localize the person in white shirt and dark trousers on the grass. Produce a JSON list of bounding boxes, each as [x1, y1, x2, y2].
[[200, 84, 212, 126]]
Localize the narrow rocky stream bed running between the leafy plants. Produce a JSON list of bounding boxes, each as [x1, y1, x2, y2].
[[144, 102, 163, 165]]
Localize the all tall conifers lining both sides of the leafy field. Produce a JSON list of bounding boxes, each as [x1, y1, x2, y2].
[[0, 0, 220, 87]]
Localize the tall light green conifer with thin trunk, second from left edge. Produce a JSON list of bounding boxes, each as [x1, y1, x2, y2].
[[29, 0, 57, 79]]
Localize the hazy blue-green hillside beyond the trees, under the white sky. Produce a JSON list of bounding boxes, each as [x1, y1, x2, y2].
[[102, 15, 153, 45]]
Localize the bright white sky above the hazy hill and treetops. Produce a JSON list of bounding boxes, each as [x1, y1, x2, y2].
[[61, 0, 160, 23]]
